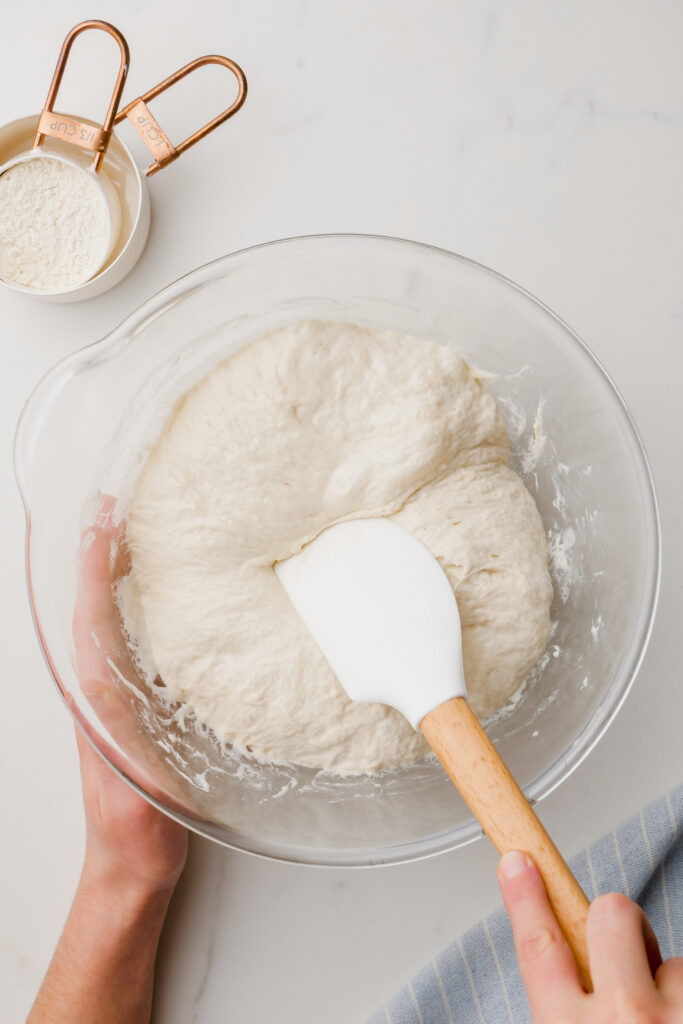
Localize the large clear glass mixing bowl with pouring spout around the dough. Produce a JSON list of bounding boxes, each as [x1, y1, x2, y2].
[[15, 236, 659, 865]]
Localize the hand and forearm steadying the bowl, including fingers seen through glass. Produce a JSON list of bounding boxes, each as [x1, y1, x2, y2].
[[29, 496, 187, 1024]]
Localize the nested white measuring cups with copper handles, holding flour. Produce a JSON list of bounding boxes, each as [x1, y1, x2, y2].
[[0, 20, 247, 302]]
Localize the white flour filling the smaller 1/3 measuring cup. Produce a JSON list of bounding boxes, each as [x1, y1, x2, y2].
[[0, 157, 110, 291]]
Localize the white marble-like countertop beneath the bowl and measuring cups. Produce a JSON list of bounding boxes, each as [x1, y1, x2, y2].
[[0, 0, 683, 1024]]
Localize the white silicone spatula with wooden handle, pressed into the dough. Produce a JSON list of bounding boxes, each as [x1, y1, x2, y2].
[[274, 519, 590, 988]]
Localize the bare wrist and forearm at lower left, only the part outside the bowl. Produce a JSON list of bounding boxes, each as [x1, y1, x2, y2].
[[27, 731, 187, 1024]]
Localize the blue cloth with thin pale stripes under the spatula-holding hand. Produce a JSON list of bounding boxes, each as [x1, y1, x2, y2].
[[368, 786, 683, 1024]]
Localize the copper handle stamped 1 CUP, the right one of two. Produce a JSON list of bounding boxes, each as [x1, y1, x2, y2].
[[114, 53, 247, 177]]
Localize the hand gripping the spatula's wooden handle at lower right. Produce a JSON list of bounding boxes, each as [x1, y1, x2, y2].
[[499, 853, 683, 1024]]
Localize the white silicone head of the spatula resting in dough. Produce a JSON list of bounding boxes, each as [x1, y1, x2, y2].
[[274, 519, 465, 729]]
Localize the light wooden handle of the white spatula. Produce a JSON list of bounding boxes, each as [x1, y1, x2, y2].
[[420, 697, 592, 991]]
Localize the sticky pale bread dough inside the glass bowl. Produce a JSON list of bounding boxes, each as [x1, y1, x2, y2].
[[123, 321, 552, 773]]
